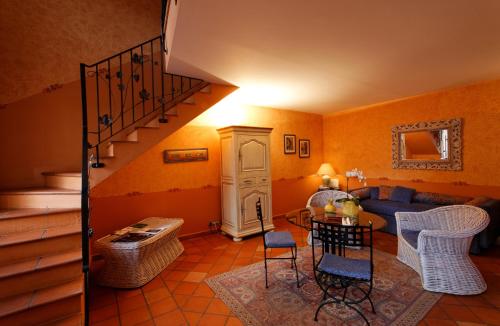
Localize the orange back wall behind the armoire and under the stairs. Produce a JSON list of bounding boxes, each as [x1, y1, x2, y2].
[[91, 101, 323, 239]]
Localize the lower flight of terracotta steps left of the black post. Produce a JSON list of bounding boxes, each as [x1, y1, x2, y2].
[[0, 173, 83, 325]]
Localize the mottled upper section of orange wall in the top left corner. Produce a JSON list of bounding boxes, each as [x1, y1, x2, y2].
[[0, 0, 161, 105]]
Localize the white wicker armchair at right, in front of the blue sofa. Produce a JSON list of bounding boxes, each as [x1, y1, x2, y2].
[[396, 205, 490, 295]]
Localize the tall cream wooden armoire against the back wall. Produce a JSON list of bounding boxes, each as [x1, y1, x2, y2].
[[217, 126, 274, 241]]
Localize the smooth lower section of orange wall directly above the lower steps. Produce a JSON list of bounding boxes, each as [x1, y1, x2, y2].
[[0, 82, 82, 189]]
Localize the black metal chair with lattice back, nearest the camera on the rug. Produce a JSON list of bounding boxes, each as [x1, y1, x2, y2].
[[312, 220, 375, 325]]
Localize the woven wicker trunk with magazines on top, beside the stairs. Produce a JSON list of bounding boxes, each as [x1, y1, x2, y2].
[[96, 217, 184, 288]]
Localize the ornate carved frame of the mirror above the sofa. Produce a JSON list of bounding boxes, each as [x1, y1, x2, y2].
[[392, 118, 462, 171]]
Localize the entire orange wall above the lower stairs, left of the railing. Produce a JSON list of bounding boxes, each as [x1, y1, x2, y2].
[[0, 0, 161, 189]]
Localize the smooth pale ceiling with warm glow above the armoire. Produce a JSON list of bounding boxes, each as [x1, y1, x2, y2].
[[169, 0, 500, 113]]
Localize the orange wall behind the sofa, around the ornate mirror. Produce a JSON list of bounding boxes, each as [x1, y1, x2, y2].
[[323, 81, 500, 197]]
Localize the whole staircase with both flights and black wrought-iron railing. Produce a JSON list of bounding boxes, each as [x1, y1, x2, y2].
[[0, 0, 236, 320]]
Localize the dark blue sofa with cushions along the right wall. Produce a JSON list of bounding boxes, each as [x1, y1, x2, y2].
[[350, 186, 500, 254]]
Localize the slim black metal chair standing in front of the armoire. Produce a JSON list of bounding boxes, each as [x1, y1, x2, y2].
[[255, 198, 300, 289]]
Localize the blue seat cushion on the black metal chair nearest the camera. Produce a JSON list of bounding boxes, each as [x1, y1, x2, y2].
[[318, 253, 371, 281]]
